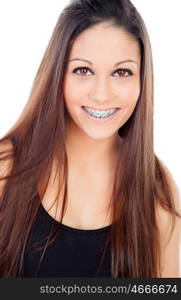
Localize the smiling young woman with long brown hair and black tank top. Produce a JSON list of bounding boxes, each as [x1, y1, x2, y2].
[[0, 0, 181, 278]]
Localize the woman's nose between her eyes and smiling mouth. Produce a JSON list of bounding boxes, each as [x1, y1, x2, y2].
[[90, 78, 112, 103]]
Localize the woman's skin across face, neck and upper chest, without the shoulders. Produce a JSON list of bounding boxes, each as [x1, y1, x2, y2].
[[41, 23, 141, 229]]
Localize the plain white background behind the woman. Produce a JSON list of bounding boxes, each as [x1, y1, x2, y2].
[[0, 0, 181, 272]]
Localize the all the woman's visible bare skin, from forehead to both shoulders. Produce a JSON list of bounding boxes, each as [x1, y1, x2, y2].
[[0, 24, 181, 278]]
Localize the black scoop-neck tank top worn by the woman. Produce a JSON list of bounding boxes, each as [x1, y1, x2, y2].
[[21, 205, 111, 277]]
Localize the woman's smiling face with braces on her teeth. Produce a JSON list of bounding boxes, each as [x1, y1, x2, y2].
[[64, 23, 141, 139]]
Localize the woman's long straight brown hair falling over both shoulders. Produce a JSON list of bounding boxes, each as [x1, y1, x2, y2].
[[0, 0, 179, 278]]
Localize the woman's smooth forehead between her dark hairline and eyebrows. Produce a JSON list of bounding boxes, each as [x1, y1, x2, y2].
[[70, 23, 140, 61]]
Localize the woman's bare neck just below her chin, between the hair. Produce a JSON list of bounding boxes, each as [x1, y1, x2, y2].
[[66, 117, 122, 173]]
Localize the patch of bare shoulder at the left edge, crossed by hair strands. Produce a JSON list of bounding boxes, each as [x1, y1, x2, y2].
[[0, 141, 13, 196]]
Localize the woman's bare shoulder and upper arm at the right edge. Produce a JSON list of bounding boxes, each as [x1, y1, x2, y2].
[[157, 163, 181, 278]]
